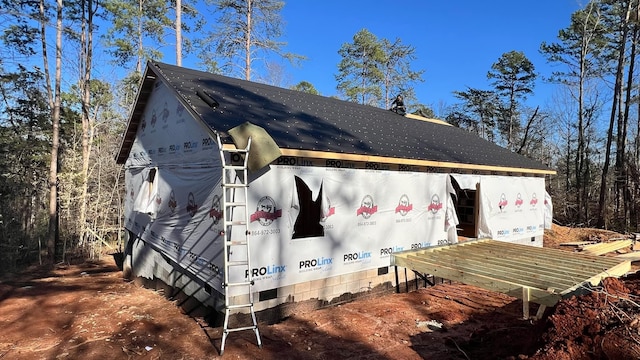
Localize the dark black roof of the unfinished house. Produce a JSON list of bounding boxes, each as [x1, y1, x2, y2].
[[117, 62, 554, 174]]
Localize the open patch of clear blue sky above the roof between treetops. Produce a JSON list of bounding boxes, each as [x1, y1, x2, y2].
[[274, 0, 582, 113]]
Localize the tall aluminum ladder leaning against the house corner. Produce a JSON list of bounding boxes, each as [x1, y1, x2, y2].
[[217, 134, 262, 355]]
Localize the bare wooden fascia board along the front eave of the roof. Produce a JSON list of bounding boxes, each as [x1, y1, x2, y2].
[[223, 144, 555, 175]]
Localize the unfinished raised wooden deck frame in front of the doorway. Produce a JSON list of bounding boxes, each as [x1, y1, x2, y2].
[[391, 240, 631, 318]]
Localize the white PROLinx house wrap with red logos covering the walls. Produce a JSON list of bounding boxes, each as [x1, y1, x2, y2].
[[125, 78, 544, 292]]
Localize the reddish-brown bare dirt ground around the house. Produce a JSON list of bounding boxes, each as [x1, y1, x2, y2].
[[0, 227, 640, 360]]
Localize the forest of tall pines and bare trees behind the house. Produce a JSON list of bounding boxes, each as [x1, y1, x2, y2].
[[0, 0, 640, 274]]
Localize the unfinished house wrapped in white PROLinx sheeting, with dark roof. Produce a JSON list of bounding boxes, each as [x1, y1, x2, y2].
[[117, 63, 553, 316]]
